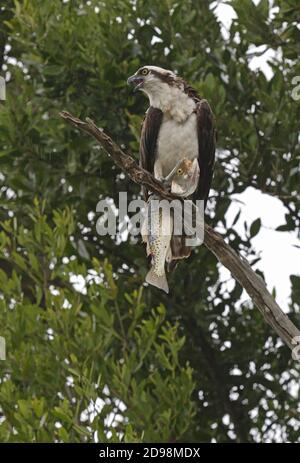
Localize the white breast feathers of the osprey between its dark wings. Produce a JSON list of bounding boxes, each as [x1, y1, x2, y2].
[[155, 113, 198, 177]]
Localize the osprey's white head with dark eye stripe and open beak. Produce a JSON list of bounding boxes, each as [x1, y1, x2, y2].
[[127, 66, 176, 96]]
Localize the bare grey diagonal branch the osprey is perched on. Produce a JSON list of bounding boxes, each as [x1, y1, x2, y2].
[[60, 111, 300, 349]]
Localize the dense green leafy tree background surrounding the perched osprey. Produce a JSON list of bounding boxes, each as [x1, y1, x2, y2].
[[0, 0, 300, 442]]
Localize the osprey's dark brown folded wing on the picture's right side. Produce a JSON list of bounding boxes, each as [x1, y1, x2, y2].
[[193, 100, 216, 207]]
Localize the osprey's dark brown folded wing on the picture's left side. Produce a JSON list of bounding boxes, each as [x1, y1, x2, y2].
[[140, 106, 163, 200]]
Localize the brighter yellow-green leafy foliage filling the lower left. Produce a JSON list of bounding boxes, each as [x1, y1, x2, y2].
[[0, 202, 195, 442]]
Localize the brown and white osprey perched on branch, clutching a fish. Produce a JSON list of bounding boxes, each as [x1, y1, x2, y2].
[[127, 66, 216, 261]]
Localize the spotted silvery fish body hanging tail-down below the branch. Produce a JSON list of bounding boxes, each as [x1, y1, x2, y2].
[[142, 195, 173, 293]]
